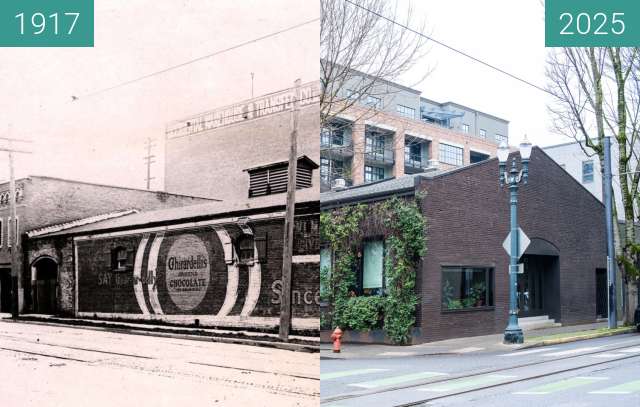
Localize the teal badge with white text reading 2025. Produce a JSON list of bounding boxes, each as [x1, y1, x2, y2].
[[545, 0, 640, 47]]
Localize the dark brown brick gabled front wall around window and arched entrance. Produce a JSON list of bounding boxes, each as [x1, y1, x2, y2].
[[416, 148, 606, 341]]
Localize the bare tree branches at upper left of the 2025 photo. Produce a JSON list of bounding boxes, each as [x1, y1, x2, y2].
[[320, 0, 426, 125]]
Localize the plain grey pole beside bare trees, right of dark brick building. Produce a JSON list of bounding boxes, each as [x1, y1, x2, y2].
[[603, 136, 626, 329]]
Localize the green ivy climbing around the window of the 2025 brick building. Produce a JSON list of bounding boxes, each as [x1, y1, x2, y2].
[[320, 198, 426, 344]]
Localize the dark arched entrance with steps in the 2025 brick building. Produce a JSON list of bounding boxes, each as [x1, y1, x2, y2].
[[518, 238, 560, 321]]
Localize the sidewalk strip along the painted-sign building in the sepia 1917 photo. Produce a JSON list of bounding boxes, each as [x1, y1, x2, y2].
[[0, 314, 320, 352]]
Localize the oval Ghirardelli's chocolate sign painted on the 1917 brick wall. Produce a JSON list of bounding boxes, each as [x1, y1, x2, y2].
[[166, 234, 210, 311]]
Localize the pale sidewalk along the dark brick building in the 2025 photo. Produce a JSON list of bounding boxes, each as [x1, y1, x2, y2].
[[320, 322, 635, 359]]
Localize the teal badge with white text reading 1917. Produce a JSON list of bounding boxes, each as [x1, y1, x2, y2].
[[0, 0, 94, 47]]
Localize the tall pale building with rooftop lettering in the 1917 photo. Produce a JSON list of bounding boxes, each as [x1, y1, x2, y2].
[[165, 82, 320, 201]]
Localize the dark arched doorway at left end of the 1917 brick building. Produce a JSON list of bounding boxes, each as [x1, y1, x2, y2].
[[31, 257, 58, 314]]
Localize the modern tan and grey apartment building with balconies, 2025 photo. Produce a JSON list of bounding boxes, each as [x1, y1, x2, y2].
[[320, 76, 509, 191]]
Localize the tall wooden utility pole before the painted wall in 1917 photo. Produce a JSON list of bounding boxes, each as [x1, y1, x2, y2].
[[279, 79, 301, 341]]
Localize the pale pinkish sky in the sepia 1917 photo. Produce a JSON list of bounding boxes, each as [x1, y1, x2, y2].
[[0, 0, 320, 189]]
